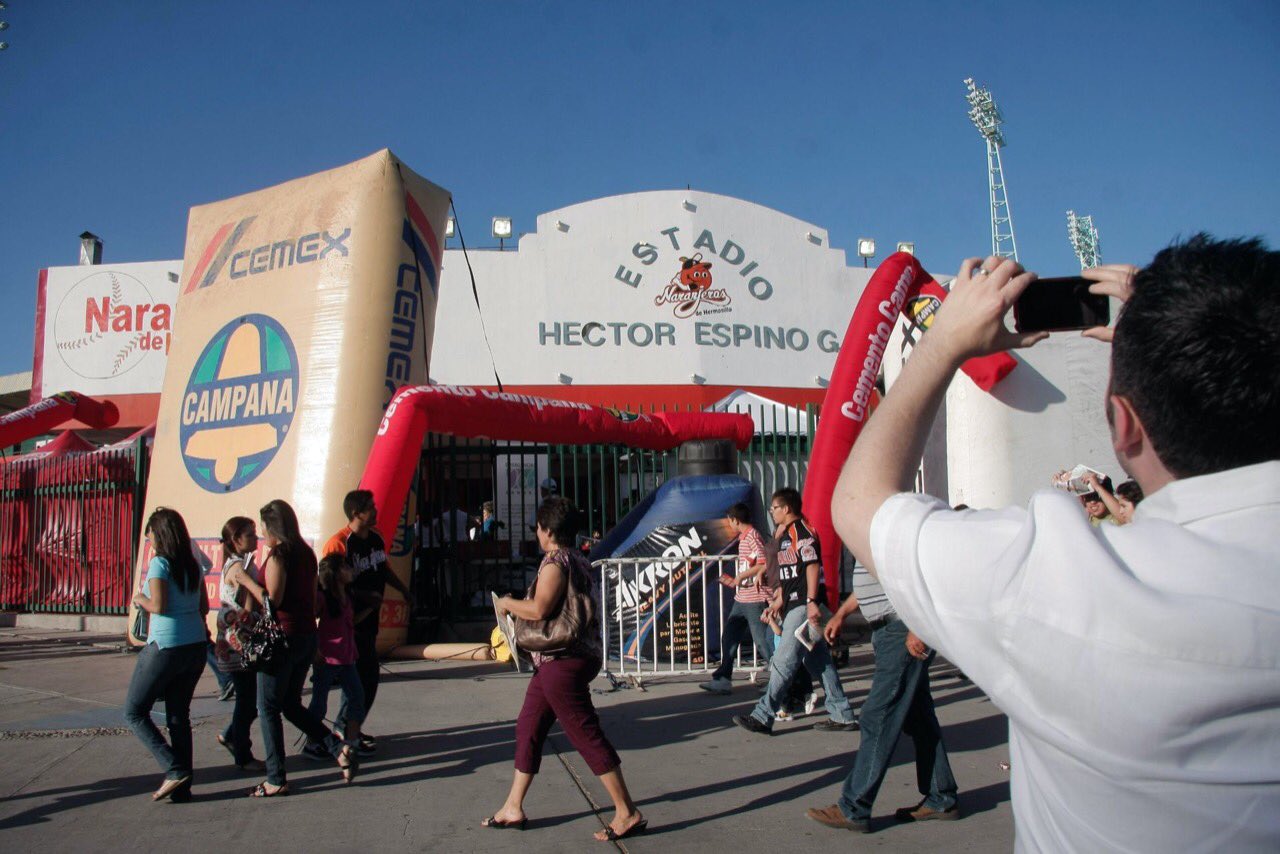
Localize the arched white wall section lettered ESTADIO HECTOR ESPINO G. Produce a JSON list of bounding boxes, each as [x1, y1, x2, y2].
[[430, 191, 870, 405]]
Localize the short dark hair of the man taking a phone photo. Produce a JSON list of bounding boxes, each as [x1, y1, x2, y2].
[[1111, 232, 1280, 478]]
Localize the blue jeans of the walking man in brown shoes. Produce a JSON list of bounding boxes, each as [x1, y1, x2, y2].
[[840, 618, 956, 821]]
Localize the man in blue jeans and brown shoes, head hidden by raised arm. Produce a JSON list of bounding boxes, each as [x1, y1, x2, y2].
[[805, 567, 960, 834]]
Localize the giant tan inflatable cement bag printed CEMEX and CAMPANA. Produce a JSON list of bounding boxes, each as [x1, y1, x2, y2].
[[131, 150, 449, 648]]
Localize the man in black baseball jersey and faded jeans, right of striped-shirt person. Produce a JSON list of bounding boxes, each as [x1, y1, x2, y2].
[[733, 488, 858, 735]]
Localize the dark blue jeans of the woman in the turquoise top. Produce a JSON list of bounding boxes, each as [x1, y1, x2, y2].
[[124, 640, 205, 780]]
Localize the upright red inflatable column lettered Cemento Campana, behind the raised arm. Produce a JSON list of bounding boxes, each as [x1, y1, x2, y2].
[[804, 252, 1018, 611]]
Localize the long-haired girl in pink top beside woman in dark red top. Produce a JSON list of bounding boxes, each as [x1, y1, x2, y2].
[[303, 554, 365, 782]]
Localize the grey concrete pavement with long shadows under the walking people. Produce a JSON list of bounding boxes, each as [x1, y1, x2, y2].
[[0, 627, 1012, 854]]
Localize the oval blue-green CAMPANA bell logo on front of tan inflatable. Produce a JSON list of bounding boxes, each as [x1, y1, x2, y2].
[[178, 314, 298, 493]]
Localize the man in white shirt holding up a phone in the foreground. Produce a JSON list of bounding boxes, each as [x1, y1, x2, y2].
[[832, 234, 1280, 851]]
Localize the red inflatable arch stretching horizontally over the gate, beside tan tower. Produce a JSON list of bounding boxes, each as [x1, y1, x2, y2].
[[360, 385, 754, 543]]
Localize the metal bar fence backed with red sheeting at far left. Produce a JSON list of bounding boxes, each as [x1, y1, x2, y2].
[[0, 439, 150, 615]]
